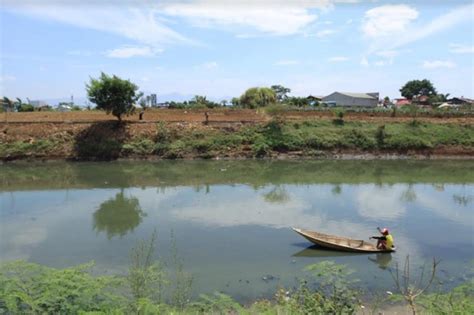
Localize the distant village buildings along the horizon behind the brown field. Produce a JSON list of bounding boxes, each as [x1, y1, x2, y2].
[[0, 91, 474, 112]]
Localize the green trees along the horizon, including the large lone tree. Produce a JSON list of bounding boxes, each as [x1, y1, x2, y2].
[[2, 73, 458, 121]]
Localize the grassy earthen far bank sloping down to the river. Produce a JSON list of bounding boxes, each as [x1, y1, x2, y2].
[[0, 112, 474, 161]]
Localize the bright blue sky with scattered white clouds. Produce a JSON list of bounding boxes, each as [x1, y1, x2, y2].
[[0, 0, 474, 101]]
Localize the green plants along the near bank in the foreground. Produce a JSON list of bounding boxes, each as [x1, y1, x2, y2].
[[0, 256, 474, 315]]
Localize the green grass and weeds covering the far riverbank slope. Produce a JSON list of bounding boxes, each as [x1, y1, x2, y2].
[[0, 118, 474, 160]]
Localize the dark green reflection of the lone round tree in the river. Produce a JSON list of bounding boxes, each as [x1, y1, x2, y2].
[[93, 190, 146, 239]]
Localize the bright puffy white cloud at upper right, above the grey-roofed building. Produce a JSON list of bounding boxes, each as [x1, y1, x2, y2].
[[362, 4, 418, 38]]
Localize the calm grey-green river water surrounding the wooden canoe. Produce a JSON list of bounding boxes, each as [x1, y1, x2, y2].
[[0, 160, 474, 302]]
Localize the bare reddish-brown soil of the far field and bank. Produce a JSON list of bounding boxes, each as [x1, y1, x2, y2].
[[0, 109, 474, 159]]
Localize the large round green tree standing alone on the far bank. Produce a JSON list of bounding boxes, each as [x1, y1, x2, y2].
[[86, 73, 142, 121]]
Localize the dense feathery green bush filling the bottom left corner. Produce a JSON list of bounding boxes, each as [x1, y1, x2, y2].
[[0, 261, 125, 314]]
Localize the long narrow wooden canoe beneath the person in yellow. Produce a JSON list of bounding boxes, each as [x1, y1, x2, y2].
[[293, 228, 395, 253]]
